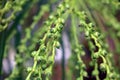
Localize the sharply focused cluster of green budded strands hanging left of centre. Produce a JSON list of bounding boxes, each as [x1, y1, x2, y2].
[[26, 2, 69, 80]]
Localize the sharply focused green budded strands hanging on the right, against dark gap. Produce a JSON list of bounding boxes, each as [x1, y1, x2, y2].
[[72, 11, 119, 80]]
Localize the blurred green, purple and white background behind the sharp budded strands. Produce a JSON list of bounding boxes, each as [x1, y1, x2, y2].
[[0, 0, 120, 80]]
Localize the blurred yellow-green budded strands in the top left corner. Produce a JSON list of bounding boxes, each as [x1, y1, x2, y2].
[[0, 0, 27, 32]]
